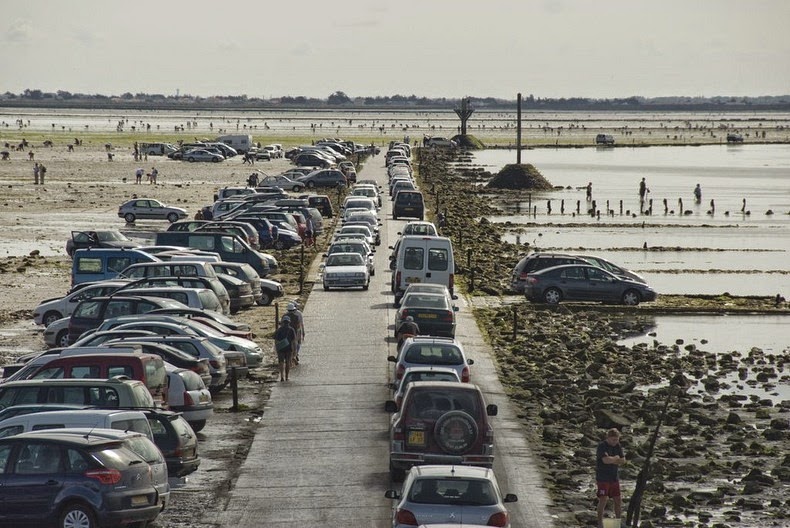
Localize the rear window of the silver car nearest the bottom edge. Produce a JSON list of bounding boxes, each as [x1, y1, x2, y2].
[[408, 477, 498, 506]]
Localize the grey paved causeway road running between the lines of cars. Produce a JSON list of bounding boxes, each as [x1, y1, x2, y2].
[[217, 156, 553, 528]]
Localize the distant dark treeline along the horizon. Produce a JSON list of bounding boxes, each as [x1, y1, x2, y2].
[[0, 89, 790, 112]]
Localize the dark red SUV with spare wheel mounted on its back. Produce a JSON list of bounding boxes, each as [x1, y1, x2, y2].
[[386, 381, 497, 480]]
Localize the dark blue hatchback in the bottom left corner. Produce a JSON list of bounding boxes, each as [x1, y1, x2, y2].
[[0, 431, 161, 528]]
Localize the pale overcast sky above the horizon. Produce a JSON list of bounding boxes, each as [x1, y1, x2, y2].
[[0, 0, 790, 99]]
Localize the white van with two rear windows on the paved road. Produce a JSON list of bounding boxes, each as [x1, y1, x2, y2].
[[392, 235, 455, 304]]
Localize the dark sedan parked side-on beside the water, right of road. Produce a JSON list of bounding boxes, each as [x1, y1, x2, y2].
[[524, 264, 658, 306]]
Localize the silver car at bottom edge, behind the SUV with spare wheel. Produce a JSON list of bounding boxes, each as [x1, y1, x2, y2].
[[384, 465, 518, 528]]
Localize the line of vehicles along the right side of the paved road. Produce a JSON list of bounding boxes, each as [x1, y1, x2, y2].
[[362, 143, 517, 527]]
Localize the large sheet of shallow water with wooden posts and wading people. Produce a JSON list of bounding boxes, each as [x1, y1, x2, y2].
[[473, 145, 790, 297]]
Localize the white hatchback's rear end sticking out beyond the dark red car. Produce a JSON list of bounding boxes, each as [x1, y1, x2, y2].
[[167, 365, 214, 433]]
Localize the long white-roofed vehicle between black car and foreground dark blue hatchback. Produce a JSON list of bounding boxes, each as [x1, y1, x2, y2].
[[0, 409, 154, 440]]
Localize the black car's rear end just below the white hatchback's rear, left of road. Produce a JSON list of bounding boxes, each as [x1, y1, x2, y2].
[[140, 409, 200, 477]]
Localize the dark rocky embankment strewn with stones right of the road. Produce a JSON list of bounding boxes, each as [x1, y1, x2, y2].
[[419, 151, 790, 528]]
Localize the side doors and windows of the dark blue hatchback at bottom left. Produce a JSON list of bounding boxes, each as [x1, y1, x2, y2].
[[0, 441, 65, 522]]
